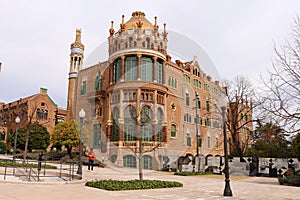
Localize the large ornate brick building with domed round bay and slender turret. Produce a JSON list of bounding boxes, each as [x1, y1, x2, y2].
[[68, 11, 252, 169]]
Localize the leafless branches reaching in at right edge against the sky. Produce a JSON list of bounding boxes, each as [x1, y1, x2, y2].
[[261, 17, 300, 133]]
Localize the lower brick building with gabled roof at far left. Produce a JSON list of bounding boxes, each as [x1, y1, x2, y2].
[[0, 88, 67, 147]]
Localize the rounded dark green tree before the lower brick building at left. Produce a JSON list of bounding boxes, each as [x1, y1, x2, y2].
[[12, 122, 50, 151]]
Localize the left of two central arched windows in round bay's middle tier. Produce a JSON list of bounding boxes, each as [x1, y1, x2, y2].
[[124, 106, 137, 141]]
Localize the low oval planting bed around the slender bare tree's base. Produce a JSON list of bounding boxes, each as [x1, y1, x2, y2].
[[85, 179, 183, 191]]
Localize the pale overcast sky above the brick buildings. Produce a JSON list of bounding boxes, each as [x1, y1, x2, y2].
[[0, 0, 300, 107]]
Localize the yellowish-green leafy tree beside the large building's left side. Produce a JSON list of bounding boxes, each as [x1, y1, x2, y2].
[[51, 120, 80, 157]]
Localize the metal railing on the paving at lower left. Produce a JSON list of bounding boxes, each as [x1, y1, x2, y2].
[[0, 159, 80, 181]]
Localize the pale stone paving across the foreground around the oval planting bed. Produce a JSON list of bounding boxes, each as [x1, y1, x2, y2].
[[0, 155, 300, 200]]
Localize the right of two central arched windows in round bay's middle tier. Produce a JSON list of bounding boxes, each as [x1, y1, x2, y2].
[[140, 106, 153, 141]]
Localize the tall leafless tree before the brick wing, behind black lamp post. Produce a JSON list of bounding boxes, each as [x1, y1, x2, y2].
[[223, 76, 255, 157]]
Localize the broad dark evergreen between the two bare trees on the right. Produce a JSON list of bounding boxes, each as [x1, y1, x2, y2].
[[251, 122, 289, 158]]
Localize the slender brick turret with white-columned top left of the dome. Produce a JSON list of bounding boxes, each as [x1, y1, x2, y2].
[[67, 29, 84, 119]]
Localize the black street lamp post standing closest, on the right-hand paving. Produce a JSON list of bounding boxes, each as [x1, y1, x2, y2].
[[220, 97, 232, 196]]
